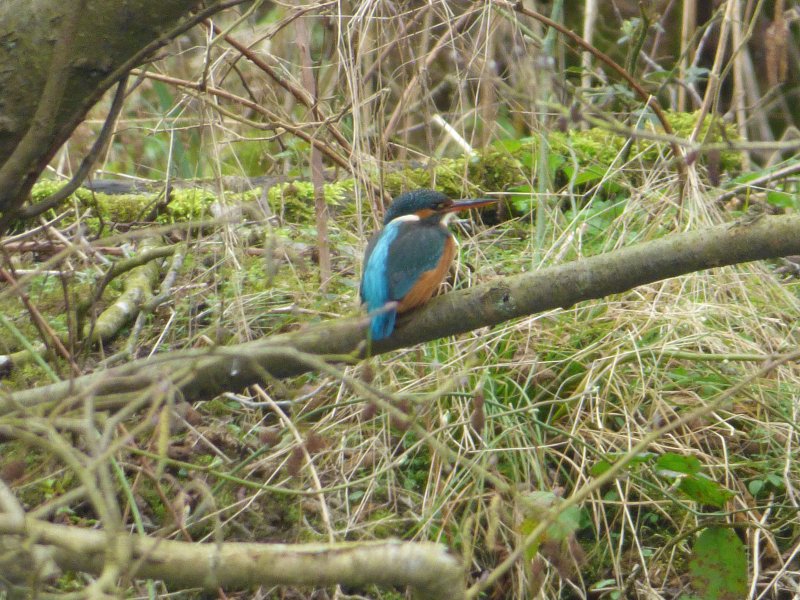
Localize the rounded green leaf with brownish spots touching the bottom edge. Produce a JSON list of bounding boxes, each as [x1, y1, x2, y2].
[[689, 527, 747, 600]]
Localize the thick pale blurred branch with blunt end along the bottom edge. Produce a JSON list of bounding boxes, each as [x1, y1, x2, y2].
[[0, 513, 464, 600]]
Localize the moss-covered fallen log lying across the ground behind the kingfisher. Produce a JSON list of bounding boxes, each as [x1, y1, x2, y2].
[[21, 113, 741, 227]]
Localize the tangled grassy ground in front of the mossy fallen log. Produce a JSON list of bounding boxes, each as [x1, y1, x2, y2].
[[0, 129, 800, 598]]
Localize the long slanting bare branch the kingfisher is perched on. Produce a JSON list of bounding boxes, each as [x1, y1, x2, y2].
[[0, 215, 800, 414]]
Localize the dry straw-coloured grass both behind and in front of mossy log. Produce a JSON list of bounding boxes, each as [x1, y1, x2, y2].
[[0, 0, 800, 599]]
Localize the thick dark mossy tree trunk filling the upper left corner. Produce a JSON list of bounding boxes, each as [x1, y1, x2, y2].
[[0, 0, 217, 225]]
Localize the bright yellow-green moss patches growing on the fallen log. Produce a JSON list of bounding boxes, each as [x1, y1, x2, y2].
[[25, 112, 741, 236]]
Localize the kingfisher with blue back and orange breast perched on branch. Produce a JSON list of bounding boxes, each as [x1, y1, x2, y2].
[[361, 190, 496, 340]]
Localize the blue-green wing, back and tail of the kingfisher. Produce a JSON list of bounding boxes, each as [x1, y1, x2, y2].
[[361, 219, 448, 340]]
